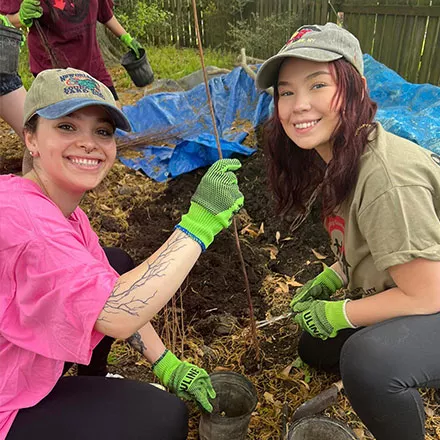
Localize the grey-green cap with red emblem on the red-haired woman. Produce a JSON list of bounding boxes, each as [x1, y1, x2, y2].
[[255, 23, 364, 90]]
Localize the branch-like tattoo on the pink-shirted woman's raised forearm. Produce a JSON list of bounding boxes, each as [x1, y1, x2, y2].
[[101, 232, 188, 321]]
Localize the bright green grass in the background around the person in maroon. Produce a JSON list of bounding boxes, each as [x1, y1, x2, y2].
[[19, 46, 236, 90]]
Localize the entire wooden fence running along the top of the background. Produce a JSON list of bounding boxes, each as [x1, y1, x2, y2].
[[129, 0, 440, 85]]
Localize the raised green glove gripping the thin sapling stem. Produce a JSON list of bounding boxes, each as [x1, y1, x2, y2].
[[176, 159, 244, 250]]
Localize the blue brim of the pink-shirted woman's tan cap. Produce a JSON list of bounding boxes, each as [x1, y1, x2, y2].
[[35, 98, 131, 131]]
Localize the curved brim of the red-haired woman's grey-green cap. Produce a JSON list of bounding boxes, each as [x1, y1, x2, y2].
[[255, 47, 342, 90]]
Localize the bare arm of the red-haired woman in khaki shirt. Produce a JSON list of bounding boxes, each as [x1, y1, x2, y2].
[[346, 258, 440, 326]]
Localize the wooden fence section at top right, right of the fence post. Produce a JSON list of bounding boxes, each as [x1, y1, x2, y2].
[[335, 0, 440, 85]]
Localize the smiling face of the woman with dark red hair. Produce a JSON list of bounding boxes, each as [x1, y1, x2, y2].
[[278, 58, 340, 163]]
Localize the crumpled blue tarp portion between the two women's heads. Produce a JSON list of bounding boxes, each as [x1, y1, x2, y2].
[[120, 68, 272, 182]]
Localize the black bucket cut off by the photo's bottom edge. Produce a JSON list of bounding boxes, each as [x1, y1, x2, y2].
[[288, 416, 358, 440]]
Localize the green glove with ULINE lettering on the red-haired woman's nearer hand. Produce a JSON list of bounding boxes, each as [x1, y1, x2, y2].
[[293, 299, 355, 340]]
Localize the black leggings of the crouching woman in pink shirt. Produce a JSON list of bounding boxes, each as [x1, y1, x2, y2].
[[6, 248, 188, 440]]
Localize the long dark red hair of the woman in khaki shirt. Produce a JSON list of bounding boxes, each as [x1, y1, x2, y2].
[[264, 59, 377, 217]]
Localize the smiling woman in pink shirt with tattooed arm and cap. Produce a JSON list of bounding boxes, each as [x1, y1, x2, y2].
[[0, 69, 243, 440]]
